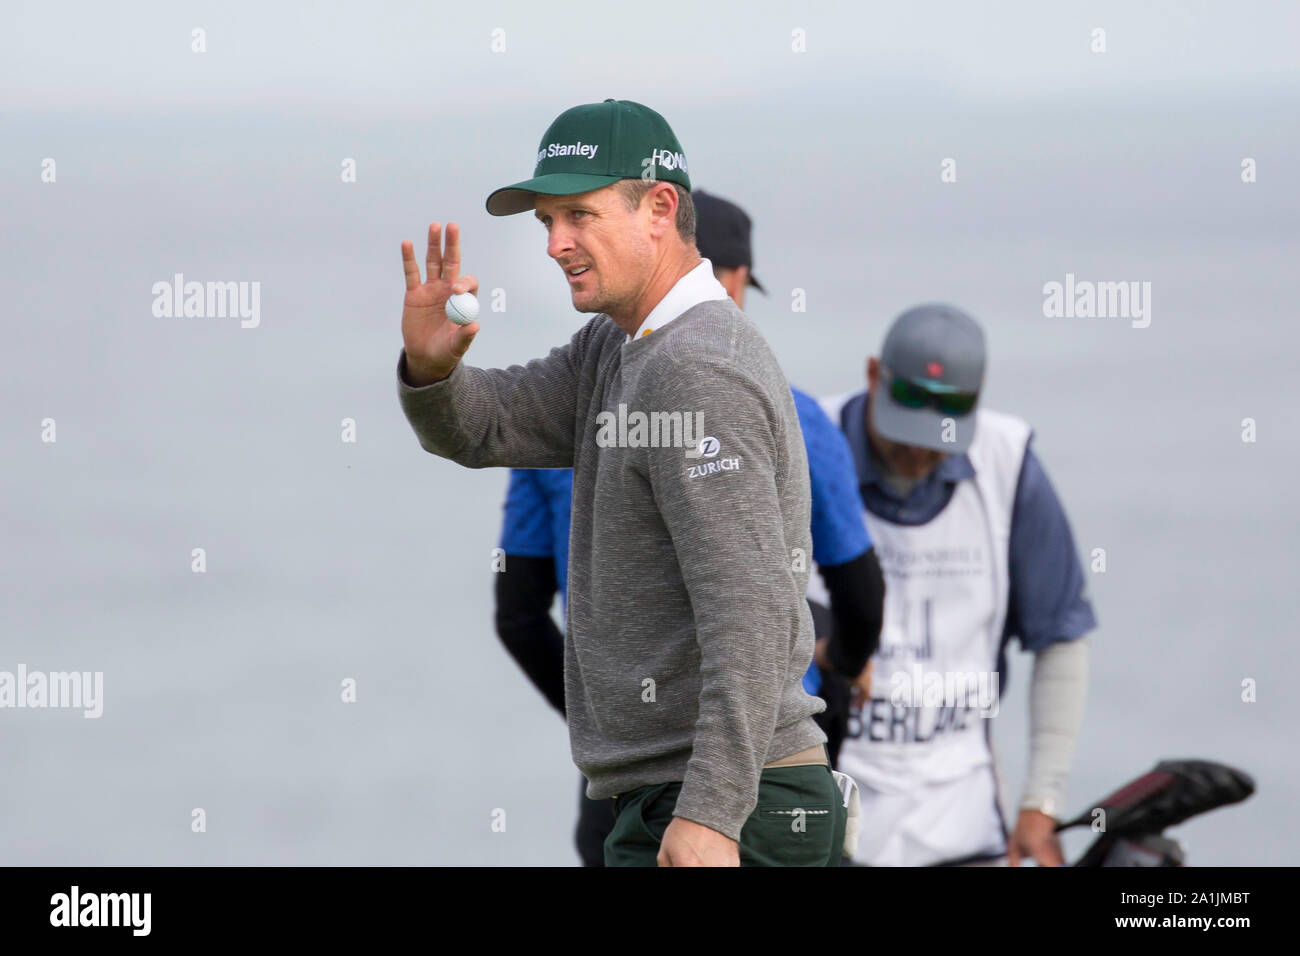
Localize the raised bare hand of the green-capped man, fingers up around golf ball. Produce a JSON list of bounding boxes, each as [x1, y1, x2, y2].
[[402, 222, 478, 388]]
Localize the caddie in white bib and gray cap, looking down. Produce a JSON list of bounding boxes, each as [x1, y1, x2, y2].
[[814, 304, 1096, 866]]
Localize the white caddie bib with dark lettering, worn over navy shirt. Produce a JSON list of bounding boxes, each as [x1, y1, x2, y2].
[[809, 395, 1031, 865]]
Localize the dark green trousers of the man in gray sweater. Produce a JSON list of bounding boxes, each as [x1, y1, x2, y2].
[[605, 765, 845, 866]]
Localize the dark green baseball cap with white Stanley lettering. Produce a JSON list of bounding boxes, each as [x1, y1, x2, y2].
[[488, 100, 690, 216]]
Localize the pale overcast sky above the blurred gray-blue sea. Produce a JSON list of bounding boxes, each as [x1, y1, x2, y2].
[[0, 0, 1300, 115]]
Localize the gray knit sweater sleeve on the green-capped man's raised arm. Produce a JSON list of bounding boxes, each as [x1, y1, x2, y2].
[[398, 316, 605, 468]]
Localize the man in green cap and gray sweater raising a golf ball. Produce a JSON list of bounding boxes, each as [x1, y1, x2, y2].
[[398, 100, 846, 866]]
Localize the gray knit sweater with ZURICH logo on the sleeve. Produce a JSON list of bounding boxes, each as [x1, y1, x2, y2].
[[398, 299, 826, 839]]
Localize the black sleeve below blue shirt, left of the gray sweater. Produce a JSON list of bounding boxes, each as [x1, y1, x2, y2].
[[495, 554, 564, 714]]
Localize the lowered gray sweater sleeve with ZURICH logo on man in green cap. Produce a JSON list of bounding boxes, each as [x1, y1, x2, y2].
[[646, 360, 807, 840]]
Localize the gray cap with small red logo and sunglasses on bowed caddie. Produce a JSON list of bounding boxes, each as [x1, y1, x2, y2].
[[871, 304, 984, 454]]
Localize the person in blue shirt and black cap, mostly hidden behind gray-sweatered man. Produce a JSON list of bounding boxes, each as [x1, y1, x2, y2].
[[494, 190, 884, 866]]
